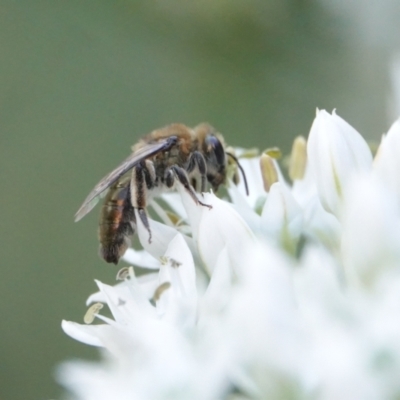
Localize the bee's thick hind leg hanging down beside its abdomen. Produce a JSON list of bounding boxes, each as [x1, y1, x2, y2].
[[131, 163, 151, 243]]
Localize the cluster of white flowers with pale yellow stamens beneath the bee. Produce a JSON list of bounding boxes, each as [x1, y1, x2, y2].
[[58, 111, 400, 400]]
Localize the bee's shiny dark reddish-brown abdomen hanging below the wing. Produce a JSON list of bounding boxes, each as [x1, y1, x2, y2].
[[99, 182, 136, 264]]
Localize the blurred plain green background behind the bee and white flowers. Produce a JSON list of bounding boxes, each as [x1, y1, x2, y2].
[[0, 0, 400, 400]]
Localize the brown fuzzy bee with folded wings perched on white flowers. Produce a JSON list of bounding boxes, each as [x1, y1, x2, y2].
[[75, 123, 248, 264]]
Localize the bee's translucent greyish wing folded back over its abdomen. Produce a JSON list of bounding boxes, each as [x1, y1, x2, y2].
[[75, 136, 178, 222]]
